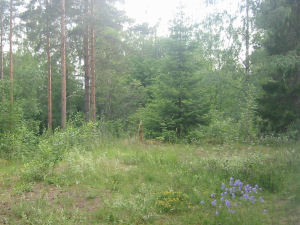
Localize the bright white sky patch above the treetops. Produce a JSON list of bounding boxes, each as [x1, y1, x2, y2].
[[117, 0, 241, 35]]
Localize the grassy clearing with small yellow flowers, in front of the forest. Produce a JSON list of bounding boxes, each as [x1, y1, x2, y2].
[[0, 139, 300, 225]]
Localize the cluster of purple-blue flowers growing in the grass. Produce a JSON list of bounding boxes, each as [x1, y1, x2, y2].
[[205, 177, 266, 215]]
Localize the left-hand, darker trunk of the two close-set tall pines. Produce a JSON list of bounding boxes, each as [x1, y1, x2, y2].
[[83, 0, 90, 122]]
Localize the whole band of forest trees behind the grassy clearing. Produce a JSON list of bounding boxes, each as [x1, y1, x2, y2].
[[0, 0, 300, 142]]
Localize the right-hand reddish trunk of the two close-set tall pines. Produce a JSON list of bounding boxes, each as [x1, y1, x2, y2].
[[91, 0, 96, 122]]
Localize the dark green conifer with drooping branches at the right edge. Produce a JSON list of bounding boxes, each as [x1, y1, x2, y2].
[[257, 0, 300, 134]]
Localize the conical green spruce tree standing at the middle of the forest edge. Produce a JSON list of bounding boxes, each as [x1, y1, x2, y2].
[[140, 11, 208, 141]]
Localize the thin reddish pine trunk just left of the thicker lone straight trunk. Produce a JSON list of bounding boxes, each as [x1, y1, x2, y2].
[[46, 0, 52, 133]]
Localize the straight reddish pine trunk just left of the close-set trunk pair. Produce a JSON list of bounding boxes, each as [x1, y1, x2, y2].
[[61, 0, 67, 129]]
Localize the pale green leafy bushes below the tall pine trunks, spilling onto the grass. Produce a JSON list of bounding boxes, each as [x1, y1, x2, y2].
[[22, 122, 99, 183]]
